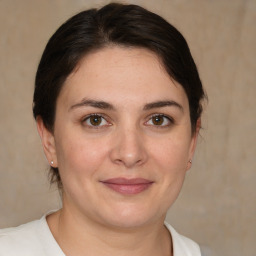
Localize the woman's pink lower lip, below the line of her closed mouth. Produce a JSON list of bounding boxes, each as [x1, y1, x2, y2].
[[103, 182, 153, 195]]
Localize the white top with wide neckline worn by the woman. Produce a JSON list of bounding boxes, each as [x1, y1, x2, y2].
[[0, 216, 201, 256]]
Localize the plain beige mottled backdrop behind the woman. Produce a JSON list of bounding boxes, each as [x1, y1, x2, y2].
[[0, 0, 256, 256]]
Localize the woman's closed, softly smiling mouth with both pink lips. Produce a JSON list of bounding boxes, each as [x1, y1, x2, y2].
[[101, 178, 154, 195]]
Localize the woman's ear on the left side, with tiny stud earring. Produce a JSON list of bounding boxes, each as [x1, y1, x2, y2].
[[36, 116, 58, 168]]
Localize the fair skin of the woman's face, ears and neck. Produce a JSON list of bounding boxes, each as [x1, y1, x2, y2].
[[37, 46, 200, 256]]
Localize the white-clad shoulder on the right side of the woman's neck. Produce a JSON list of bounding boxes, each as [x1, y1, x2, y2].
[[165, 222, 201, 256]]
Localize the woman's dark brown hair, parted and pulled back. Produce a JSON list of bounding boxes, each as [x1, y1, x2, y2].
[[33, 3, 205, 188]]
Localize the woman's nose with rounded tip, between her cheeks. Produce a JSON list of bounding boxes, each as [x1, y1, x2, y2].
[[110, 125, 148, 168]]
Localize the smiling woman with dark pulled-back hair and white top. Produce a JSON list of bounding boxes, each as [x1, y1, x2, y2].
[[0, 4, 204, 256]]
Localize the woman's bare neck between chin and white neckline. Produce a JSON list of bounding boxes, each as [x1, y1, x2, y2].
[[47, 207, 172, 256]]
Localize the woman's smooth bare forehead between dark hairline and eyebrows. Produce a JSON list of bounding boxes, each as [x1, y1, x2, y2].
[[59, 46, 187, 109]]
